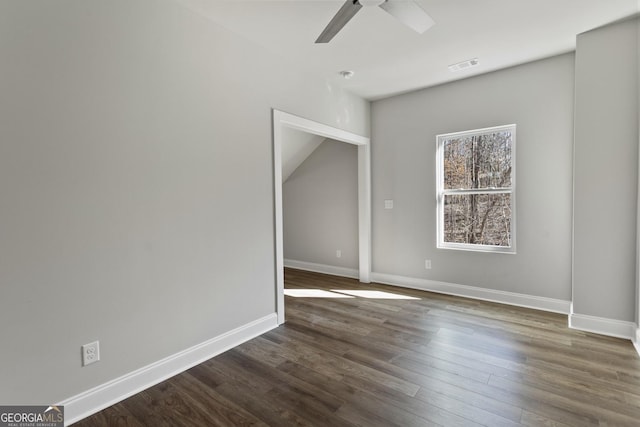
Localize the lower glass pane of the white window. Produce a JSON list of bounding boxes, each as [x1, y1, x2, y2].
[[443, 194, 511, 246]]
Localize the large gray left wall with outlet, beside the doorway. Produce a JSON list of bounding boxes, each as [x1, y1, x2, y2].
[[0, 0, 369, 404]]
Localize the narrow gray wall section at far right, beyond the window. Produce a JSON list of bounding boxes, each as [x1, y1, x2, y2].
[[573, 21, 638, 321]]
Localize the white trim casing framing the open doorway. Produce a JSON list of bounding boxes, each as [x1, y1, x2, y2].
[[273, 110, 371, 324]]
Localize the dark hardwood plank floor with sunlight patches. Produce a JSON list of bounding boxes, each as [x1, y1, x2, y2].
[[76, 270, 640, 427]]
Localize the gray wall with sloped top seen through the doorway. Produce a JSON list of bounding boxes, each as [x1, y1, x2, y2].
[[282, 140, 358, 269]]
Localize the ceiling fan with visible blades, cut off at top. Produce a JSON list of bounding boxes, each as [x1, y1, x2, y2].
[[316, 0, 435, 43]]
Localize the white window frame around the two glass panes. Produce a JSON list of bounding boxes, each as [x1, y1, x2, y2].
[[436, 124, 516, 254]]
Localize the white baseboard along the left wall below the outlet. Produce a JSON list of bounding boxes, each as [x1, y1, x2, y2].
[[59, 313, 278, 425]]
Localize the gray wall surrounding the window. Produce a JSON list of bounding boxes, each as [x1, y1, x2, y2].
[[371, 54, 574, 300]]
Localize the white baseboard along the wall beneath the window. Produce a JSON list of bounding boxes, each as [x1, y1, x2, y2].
[[371, 273, 571, 314]]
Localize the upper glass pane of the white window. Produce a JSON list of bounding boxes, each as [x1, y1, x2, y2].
[[443, 131, 512, 190]]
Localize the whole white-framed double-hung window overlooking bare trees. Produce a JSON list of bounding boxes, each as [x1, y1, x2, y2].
[[437, 125, 516, 253]]
